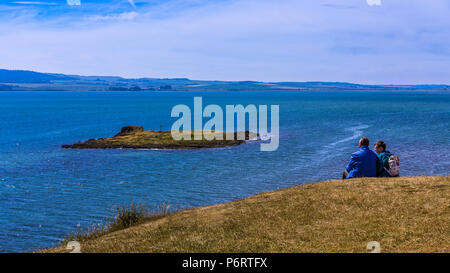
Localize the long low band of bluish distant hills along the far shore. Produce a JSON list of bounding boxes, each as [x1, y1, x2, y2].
[[0, 69, 450, 91]]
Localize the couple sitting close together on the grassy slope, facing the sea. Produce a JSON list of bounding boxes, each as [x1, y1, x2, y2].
[[342, 137, 400, 179]]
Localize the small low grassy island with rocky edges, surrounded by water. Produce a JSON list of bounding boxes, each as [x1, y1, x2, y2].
[[62, 126, 258, 149]]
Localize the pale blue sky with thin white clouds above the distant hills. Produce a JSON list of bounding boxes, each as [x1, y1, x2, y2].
[[0, 0, 450, 84]]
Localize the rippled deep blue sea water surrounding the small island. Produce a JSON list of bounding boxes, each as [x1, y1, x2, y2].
[[0, 91, 450, 252]]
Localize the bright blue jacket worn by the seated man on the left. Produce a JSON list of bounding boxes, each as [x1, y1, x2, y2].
[[345, 145, 378, 179]]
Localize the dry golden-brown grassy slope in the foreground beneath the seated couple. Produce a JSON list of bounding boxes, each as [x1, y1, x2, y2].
[[44, 177, 450, 252]]
